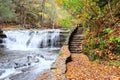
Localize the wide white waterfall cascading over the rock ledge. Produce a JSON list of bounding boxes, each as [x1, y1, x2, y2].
[[2, 29, 60, 50]]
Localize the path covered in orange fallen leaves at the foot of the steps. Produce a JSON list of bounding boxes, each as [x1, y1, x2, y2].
[[66, 54, 120, 80]]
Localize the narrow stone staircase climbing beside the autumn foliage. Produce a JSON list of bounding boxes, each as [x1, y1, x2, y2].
[[69, 27, 83, 53]]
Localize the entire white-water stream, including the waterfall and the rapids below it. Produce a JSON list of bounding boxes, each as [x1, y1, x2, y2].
[[0, 29, 60, 80]]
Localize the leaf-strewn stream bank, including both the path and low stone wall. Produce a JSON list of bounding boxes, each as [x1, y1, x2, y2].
[[37, 46, 120, 80]]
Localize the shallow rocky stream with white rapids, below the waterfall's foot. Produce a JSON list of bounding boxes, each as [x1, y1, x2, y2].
[[0, 49, 58, 80]]
